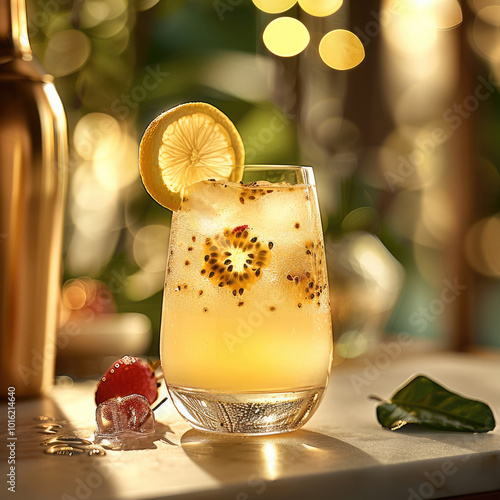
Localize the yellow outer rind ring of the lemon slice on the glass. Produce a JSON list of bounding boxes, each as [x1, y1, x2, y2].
[[139, 102, 245, 212]]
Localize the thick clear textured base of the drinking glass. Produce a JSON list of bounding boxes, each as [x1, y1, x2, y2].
[[168, 385, 325, 435]]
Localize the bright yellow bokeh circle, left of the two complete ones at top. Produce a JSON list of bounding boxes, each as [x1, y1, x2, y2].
[[262, 17, 310, 57]]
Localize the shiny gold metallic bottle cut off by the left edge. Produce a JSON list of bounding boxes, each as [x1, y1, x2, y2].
[[0, 0, 68, 398]]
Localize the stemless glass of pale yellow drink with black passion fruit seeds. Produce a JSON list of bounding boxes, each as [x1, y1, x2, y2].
[[161, 166, 332, 434]]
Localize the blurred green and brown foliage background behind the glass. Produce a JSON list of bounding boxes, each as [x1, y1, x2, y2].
[[28, 0, 500, 368]]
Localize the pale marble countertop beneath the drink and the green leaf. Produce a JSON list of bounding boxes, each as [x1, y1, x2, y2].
[[0, 353, 500, 500]]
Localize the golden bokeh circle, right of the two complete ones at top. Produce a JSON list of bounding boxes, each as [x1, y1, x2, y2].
[[319, 30, 365, 70]]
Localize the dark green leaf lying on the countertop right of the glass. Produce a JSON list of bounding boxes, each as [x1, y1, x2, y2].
[[377, 375, 495, 432]]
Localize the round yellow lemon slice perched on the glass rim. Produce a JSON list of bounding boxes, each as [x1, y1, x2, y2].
[[139, 102, 245, 211]]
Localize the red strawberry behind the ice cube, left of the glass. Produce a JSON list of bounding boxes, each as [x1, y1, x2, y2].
[[95, 356, 159, 405]]
